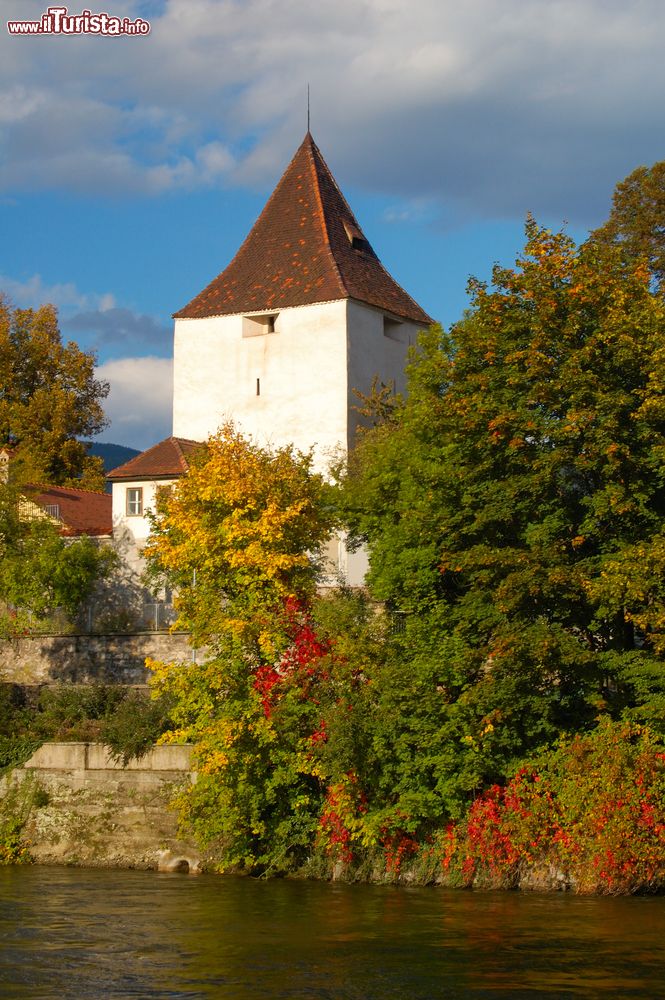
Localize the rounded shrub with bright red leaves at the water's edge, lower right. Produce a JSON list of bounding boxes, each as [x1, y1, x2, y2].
[[438, 719, 665, 893]]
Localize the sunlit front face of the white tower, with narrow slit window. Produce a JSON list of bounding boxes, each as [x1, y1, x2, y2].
[[173, 300, 347, 463]]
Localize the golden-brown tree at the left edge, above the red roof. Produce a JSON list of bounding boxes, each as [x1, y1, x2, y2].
[[0, 295, 108, 489]]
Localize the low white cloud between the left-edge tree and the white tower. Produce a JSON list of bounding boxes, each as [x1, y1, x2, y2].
[[97, 357, 173, 450]]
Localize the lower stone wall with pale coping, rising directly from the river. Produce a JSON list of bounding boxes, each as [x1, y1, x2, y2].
[[0, 743, 201, 872]]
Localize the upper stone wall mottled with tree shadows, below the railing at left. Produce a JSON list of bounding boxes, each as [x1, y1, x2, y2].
[[0, 632, 194, 684]]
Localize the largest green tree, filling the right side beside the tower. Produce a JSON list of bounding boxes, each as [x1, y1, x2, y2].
[[345, 215, 665, 826]]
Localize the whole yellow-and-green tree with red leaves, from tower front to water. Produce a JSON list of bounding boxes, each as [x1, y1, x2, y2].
[[146, 425, 332, 871]]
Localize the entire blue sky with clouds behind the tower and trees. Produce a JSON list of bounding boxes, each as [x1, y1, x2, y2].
[[0, 0, 665, 449]]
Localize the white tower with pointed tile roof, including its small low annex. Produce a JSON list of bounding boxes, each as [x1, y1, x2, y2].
[[110, 132, 432, 584]]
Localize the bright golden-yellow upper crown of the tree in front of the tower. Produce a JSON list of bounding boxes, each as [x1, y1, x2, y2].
[[145, 424, 333, 656]]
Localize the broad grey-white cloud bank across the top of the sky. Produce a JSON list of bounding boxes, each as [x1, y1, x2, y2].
[[0, 0, 665, 217]]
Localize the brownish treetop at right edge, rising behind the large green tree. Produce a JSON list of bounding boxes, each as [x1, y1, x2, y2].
[[591, 160, 665, 291]]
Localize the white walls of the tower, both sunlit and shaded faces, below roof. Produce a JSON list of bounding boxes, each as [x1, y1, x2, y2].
[[173, 299, 418, 469]]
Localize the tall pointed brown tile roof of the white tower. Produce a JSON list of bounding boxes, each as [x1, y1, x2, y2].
[[174, 132, 432, 326]]
